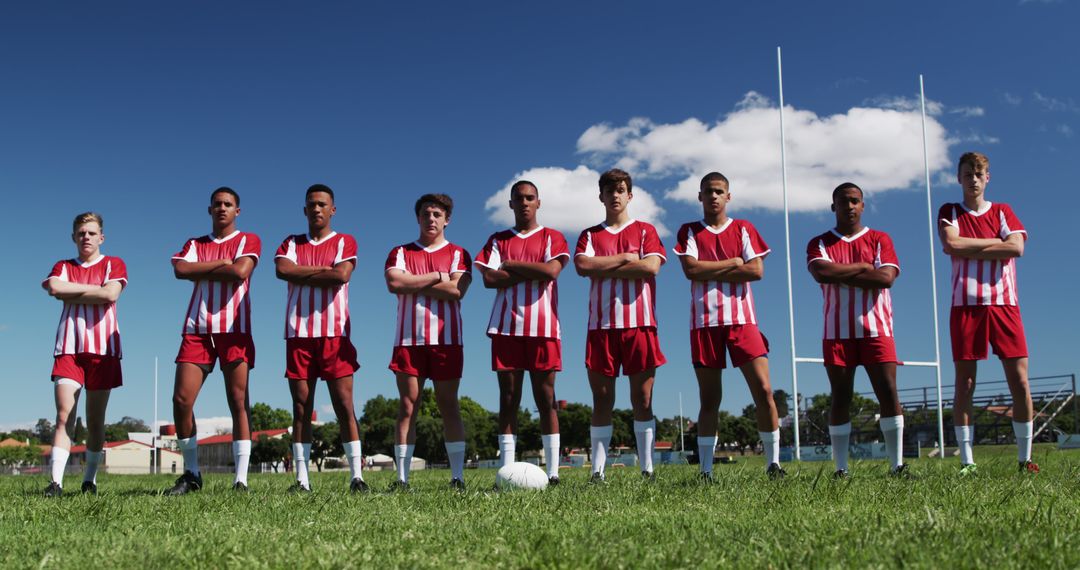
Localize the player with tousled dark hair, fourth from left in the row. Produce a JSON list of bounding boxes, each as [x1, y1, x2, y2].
[[386, 194, 472, 491]]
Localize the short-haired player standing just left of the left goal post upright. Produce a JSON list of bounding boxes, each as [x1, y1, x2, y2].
[[674, 172, 784, 481]]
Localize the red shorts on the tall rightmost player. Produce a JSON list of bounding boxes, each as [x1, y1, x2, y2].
[[949, 304, 1027, 361]]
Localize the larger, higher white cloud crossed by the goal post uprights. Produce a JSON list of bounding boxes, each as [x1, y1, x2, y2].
[[578, 93, 949, 211]]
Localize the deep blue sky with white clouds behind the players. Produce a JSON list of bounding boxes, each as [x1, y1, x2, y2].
[[0, 1, 1080, 429]]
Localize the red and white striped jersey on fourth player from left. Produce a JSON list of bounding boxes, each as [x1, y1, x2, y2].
[[387, 242, 472, 347]]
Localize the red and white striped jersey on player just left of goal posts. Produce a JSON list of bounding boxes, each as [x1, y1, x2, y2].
[[674, 218, 771, 328]]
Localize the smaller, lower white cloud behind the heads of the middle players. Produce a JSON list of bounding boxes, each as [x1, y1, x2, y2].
[[484, 165, 671, 236]]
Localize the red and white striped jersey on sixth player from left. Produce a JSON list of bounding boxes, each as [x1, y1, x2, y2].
[[573, 220, 667, 330]]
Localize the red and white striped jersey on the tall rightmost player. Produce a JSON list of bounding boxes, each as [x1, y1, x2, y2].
[[937, 202, 1027, 307]]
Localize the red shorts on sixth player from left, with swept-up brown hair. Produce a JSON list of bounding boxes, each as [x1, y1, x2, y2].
[[585, 327, 667, 377]]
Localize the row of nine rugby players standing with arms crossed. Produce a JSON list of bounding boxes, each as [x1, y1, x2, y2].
[[42, 152, 1038, 497]]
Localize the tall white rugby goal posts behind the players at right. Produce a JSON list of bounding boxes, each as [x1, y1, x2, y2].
[[777, 46, 945, 461]]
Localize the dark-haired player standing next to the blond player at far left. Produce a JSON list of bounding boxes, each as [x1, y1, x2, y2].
[[165, 187, 262, 494]]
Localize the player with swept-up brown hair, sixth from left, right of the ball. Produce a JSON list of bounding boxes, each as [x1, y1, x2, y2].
[[573, 168, 667, 483]]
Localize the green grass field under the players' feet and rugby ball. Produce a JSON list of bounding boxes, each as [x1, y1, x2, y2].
[[0, 446, 1080, 568]]
